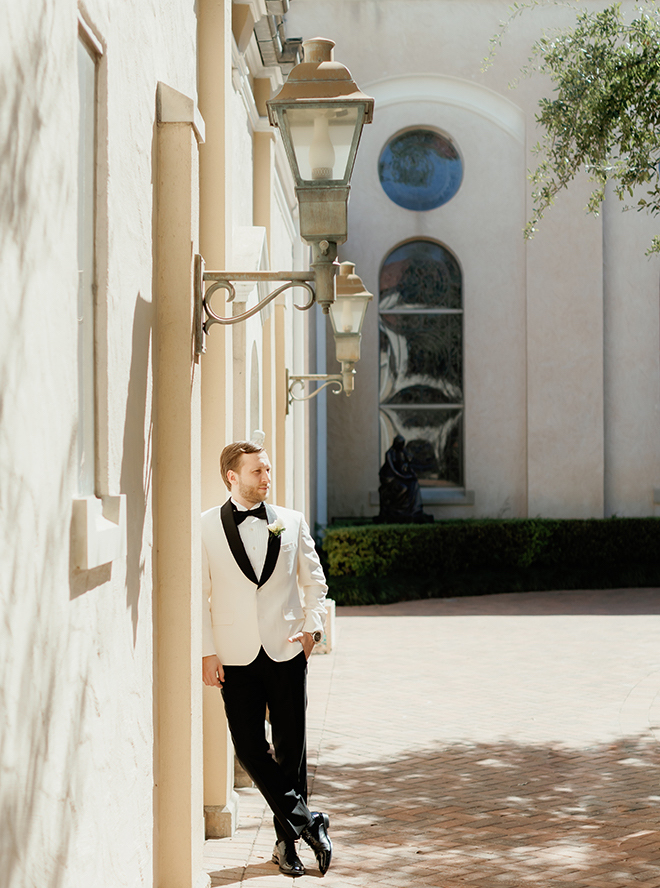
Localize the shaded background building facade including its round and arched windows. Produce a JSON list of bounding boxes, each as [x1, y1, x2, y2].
[[287, 0, 660, 520]]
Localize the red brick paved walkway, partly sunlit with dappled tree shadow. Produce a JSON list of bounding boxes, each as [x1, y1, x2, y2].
[[206, 589, 660, 888]]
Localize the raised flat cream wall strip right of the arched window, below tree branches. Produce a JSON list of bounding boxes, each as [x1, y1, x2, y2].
[[527, 180, 604, 518]]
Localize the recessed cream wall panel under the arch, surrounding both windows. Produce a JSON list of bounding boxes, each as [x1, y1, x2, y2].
[[328, 77, 526, 515]]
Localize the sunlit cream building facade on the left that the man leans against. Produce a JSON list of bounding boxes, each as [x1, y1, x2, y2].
[[0, 0, 318, 888]]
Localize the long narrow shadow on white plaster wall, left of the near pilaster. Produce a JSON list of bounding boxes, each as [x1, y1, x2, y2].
[[120, 293, 153, 645]]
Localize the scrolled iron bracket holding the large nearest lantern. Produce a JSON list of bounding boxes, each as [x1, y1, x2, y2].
[[194, 254, 316, 357]]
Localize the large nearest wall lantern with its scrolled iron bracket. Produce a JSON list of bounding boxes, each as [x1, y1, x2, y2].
[[195, 37, 374, 394]]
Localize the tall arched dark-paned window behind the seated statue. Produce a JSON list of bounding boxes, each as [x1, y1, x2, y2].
[[379, 240, 463, 487]]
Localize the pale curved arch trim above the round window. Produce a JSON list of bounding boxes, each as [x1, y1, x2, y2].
[[362, 74, 525, 144]]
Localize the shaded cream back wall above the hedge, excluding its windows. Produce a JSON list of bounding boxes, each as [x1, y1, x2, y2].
[[287, 0, 660, 518]]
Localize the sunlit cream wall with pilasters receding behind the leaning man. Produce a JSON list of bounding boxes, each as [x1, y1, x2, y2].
[[199, 0, 308, 836]]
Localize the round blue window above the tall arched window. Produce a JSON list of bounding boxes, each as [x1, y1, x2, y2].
[[378, 129, 463, 210]]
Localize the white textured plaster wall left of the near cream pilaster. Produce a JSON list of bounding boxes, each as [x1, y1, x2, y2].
[[0, 0, 196, 888]]
